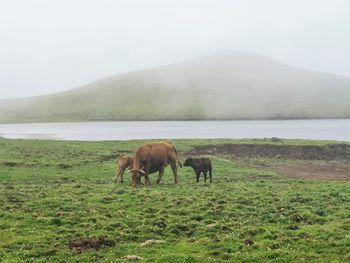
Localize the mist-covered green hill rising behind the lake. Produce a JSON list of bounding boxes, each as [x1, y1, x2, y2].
[[0, 51, 350, 122]]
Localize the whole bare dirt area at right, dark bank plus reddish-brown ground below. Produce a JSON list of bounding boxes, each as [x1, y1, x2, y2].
[[187, 144, 350, 181]]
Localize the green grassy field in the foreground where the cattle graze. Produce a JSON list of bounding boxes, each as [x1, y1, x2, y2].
[[0, 139, 350, 262]]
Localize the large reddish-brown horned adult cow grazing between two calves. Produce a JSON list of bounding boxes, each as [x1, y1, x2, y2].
[[132, 141, 182, 186]]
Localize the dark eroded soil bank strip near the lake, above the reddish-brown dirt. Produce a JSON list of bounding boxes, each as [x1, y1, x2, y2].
[[189, 144, 350, 160]]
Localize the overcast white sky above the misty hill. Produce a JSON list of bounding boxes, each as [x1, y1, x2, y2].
[[0, 0, 350, 99]]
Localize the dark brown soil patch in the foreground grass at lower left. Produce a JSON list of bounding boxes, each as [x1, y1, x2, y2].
[[69, 237, 115, 253]]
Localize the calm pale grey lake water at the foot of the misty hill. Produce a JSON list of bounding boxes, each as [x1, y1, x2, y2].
[[0, 119, 350, 141]]
